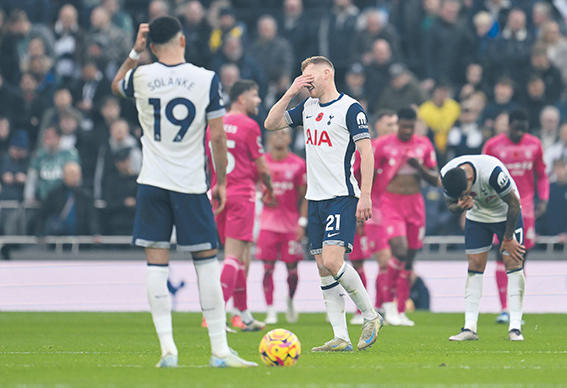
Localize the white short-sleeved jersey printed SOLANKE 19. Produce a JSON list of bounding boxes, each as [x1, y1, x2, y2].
[[121, 62, 226, 194]]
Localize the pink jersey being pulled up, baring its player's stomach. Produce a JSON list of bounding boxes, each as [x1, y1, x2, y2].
[[372, 133, 437, 200]]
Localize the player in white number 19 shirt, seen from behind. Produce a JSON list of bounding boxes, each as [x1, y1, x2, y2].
[[112, 17, 257, 368]]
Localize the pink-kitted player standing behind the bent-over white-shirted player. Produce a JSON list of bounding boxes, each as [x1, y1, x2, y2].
[[482, 109, 549, 323]]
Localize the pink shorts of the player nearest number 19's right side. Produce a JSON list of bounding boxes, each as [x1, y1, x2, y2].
[[215, 196, 256, 245]]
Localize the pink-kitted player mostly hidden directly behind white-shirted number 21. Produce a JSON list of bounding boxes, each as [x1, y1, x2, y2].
[[348, 109, 398, 325]]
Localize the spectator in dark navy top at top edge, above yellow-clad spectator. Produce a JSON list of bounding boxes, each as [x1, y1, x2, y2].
[[423, 0, 474, 83]]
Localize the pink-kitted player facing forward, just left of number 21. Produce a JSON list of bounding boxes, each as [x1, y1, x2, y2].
[[255, 128, 307, 324]]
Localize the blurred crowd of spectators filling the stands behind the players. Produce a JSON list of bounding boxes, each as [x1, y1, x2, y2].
[[0, 0, 567, 252]]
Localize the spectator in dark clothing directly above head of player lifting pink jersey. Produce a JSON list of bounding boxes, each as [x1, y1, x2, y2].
[[371, 63, 427, 112]]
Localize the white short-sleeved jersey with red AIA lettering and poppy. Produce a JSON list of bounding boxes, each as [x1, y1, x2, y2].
[[284, 94, 370, 201]]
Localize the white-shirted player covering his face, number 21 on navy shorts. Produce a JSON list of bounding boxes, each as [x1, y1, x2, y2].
[[265, 56, 382, 352]]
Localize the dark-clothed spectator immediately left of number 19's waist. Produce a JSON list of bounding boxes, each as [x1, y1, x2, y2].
[[101, 148, 138, 236]]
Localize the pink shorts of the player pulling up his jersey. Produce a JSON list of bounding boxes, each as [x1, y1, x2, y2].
[[380, 191, 425, 249]]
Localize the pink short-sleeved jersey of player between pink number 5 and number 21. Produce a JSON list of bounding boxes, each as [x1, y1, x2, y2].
[[260, 153, 307, 233]]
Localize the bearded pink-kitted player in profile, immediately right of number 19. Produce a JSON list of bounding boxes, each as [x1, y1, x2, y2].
[[210, 80, 273, 331]]
